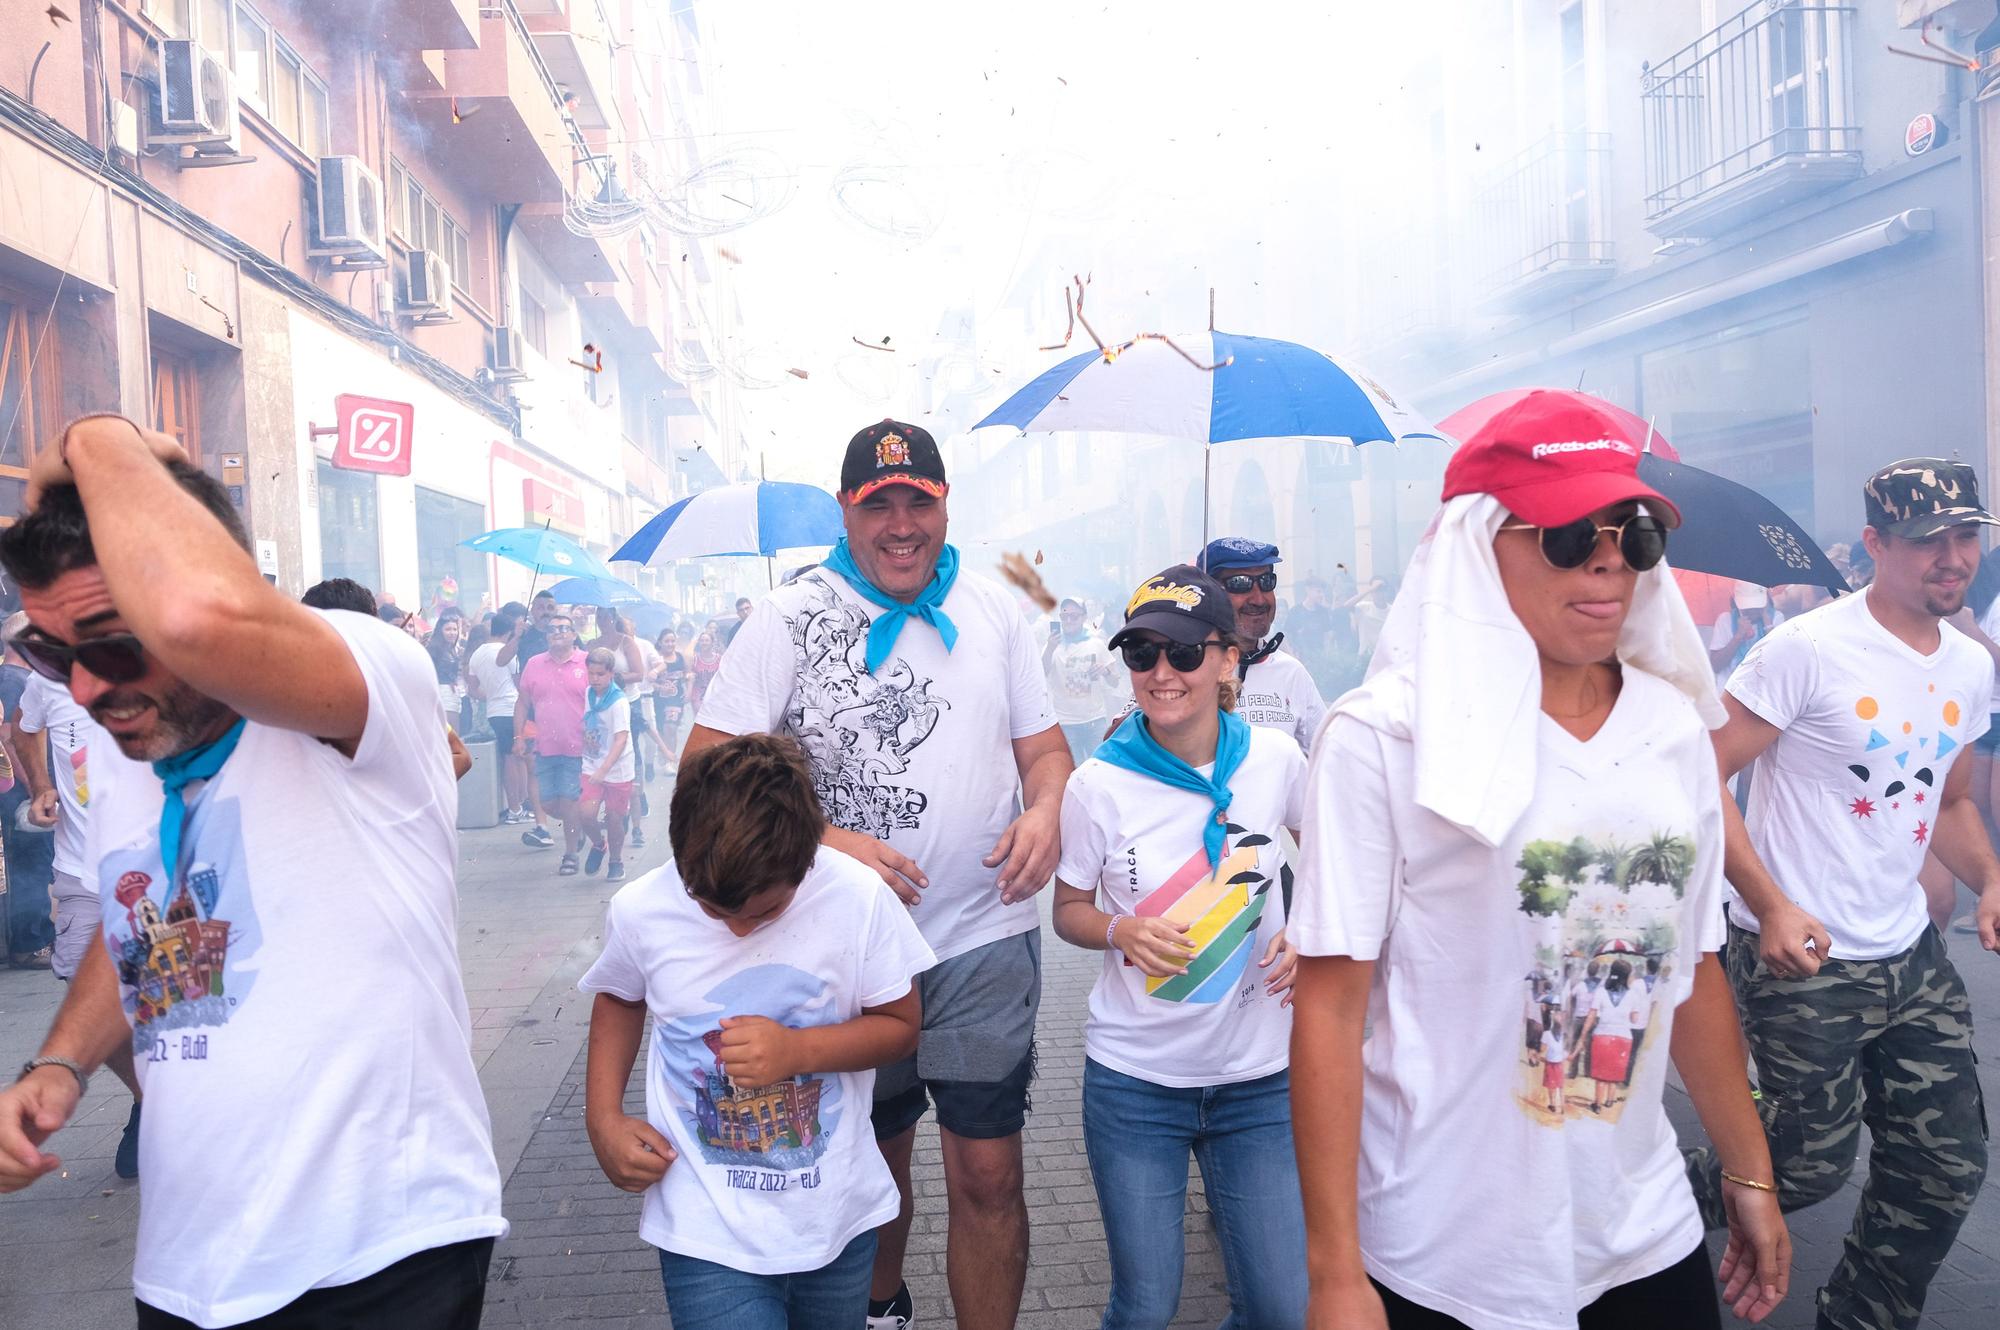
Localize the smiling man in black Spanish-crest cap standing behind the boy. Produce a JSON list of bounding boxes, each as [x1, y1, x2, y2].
[[682, 420, 1070, 1330]]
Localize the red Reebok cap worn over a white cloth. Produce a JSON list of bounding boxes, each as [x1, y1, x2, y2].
[[1444, 392, 1680, 526]]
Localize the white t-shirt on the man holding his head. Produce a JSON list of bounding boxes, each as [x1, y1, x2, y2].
[[86, 610, 506, 1326]]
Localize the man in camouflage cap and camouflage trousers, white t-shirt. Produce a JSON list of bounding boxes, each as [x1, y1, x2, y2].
[[1696, 458, 2000, 1330]]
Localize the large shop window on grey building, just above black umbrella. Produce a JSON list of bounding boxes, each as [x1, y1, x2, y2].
[[1638, 310, 1814, 532]]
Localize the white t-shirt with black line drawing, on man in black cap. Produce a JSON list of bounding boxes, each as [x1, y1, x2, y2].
[[696, 568, 1056, 960]]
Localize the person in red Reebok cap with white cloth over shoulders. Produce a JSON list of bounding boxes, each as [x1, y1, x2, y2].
[[1290, 394, 1790, 1330]]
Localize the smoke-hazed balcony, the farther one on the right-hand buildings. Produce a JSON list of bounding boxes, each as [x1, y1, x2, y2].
[[1472, 130, 1614, 312]]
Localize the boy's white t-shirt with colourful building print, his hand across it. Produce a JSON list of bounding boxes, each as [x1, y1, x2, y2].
[[578, 850, 936, 1274]]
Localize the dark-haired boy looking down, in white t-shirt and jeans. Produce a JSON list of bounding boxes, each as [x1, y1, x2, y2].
[[578, 734, 936, 1330]]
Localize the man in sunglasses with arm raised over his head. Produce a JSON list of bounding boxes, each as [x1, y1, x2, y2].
[[0, 416, 506, 1330]]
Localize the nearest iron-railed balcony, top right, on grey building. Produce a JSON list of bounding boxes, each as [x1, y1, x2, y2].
[[1640, 0, 1862, 236]]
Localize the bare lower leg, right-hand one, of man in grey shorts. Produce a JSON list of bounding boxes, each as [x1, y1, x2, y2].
[[938, 1128, 1028, 1330]]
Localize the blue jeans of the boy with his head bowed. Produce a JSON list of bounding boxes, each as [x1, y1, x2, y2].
[[660, 1228, 876, 1330]]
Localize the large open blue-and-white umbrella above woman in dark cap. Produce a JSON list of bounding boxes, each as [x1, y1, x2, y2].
[[972, 332, 1444, 444]]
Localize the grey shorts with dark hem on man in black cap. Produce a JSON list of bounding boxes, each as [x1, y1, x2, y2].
[[874, 930, 1042, 1140]]
